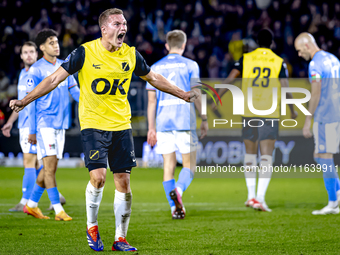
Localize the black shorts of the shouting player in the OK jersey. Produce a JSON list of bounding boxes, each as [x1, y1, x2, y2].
[[81, 128, 136, 173]]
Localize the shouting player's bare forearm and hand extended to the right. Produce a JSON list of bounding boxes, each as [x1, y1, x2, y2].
[[140, 70, 198, 102]]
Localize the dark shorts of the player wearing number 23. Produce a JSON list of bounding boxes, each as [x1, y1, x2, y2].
[[242, 117, 279, 142]]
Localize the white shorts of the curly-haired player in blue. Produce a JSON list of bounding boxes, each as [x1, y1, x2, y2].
[[37, 128, 65, 160]]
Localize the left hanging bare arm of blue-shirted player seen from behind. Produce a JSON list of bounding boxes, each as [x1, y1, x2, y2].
[[147, 90, 157, 146]]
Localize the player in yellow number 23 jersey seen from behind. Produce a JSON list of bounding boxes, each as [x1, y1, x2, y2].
[[217, 29, 297, 212]]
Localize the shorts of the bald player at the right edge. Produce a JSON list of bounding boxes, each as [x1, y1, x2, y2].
[[313, 122, 340, 154]]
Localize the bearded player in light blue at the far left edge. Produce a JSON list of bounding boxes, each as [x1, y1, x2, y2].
[[1, 41, 42, 212]]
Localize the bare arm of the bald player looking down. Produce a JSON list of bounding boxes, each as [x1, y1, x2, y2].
[[302, 81, 321, 138]]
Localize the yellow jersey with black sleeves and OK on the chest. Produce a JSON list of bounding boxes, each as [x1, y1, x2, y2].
[[62, 39, 150, 131]]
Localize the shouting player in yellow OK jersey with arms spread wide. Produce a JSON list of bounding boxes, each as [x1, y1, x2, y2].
[[10, 8, 198, 251]]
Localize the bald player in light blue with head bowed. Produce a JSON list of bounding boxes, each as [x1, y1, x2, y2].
[[294, 33, 340, 215]]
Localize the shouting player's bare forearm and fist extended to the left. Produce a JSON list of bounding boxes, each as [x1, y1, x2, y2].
[[9, 67, 69, 112]]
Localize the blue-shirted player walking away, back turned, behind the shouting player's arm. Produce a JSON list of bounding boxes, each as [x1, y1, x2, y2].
[[146, 30, 208, 219]]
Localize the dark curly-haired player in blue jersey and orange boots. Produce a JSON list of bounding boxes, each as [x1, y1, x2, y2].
[[24, 29, 79, 221]]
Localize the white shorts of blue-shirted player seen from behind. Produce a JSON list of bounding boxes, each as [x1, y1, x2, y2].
[[156, 131, 198, 154]]
